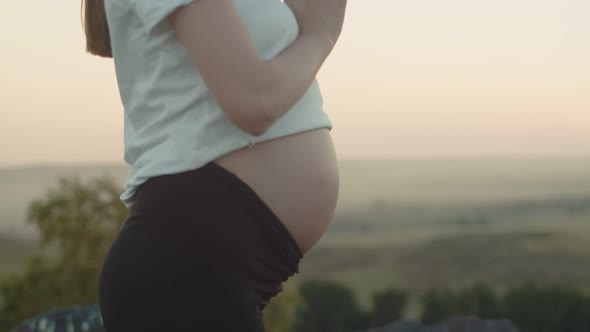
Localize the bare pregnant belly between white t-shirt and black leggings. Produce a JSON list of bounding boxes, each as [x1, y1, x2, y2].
[[215, 128, 339, 253]]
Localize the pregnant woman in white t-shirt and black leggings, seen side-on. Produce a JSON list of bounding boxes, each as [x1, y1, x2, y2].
[[82, 0, 346, 332]]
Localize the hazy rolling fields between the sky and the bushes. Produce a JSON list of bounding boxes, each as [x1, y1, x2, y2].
[[0, 159, 590, 316]]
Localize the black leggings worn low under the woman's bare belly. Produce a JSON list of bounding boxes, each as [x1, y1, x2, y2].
[[99, 162, 303, 332]]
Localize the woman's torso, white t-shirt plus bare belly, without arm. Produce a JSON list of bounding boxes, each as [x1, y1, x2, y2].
[[105, 0, 339, 252]]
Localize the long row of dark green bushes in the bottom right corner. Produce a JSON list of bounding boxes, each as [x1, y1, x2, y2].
[[422, 283, 590, 332]]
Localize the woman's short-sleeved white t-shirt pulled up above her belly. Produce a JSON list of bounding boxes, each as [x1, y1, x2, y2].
[[105, 0, 332, 207]]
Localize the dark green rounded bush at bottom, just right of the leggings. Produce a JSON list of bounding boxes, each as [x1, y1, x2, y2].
[[294, 280, 369, 332]]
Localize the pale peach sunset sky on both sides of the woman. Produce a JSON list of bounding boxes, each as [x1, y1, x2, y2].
[[0, 0, 590, 166]]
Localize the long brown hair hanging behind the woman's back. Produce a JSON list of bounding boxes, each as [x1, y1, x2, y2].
[[80, 0, 113, 58]]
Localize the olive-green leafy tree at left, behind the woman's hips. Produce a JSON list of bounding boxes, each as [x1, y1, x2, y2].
[[0, 176, 127, 331]]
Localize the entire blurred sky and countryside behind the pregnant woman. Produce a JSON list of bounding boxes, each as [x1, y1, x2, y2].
[[0, 0, 590, 332]]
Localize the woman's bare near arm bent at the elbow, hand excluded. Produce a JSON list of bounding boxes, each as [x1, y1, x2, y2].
[[170, 0, 334, 135]]
